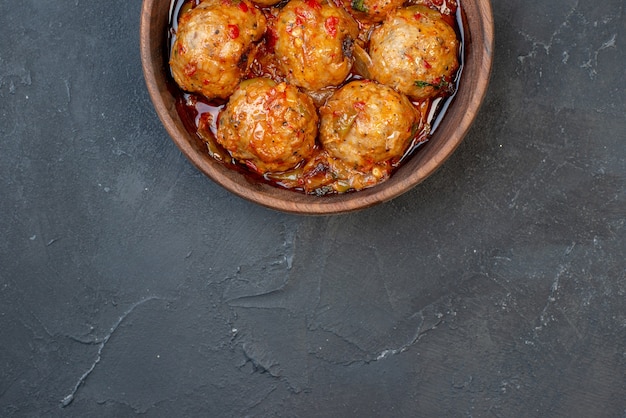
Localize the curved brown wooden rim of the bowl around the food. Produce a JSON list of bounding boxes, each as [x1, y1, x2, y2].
[[139, 0, 494, 215]]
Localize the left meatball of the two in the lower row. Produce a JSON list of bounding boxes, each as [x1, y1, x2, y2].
[[217, 78, 318, 174]]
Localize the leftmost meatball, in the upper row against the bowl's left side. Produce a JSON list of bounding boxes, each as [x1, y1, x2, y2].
[[170, 0, 266, 99]]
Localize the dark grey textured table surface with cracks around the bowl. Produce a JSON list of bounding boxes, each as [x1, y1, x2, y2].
[[0, 0, 626, 417]]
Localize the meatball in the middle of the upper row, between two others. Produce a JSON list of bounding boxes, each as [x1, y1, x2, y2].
[[274, 0, 359, 91]]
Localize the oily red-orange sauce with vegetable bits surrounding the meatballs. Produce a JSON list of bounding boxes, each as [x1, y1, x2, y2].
[[168, 0, 464, 195]]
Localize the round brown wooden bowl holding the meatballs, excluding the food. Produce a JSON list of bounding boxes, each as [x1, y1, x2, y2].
[[140, 0, 494, 215]]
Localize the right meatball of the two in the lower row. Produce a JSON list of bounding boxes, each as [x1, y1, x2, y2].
[[320, 80, 421, 172]]
